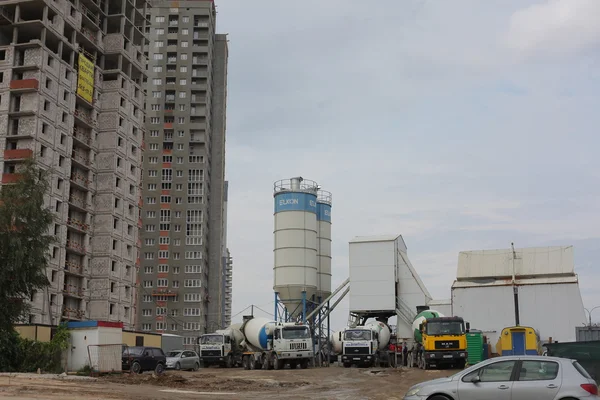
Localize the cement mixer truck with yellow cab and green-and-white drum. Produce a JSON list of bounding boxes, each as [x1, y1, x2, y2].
[[412, 310, 469, 369]]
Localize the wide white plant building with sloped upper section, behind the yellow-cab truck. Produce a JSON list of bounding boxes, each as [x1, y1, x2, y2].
[[452, 246, 586, 346]]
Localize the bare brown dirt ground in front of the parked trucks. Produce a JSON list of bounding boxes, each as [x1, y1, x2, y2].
[[0, 366, 456, 400]]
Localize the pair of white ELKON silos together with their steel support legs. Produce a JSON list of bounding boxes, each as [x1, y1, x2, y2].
[[273, 177, 332, 364]]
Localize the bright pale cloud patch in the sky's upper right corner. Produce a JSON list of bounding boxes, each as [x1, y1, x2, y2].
[[507, 0, 600, 56]]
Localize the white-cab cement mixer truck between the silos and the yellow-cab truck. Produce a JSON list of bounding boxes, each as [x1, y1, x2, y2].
[[332, 321, 391, 368]]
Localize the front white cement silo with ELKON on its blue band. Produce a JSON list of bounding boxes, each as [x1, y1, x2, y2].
[[273, 177, 318, 319]]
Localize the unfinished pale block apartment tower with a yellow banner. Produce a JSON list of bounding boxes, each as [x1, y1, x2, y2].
[[0, 0, 149, 328]]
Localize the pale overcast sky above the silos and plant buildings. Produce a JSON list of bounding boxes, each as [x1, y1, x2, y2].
[[217, 0, 600, 328]]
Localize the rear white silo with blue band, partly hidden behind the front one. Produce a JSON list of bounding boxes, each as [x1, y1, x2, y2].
[[317, 190, 331, 301]]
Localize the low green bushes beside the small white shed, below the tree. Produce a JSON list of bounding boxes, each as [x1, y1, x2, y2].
[[0, 325, 69, 374]]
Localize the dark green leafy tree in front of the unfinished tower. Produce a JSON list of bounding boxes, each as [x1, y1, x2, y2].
[[0, 160, 54, 335]]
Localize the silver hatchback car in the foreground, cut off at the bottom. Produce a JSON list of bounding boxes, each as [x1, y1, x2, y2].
[[404, 356, 598, 400]]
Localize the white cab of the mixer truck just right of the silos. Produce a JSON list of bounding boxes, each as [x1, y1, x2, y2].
[[339, 326, 379, 368]]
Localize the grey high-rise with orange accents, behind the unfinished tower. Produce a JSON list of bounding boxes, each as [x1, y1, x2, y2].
[[138, 0, 228, 344]]
